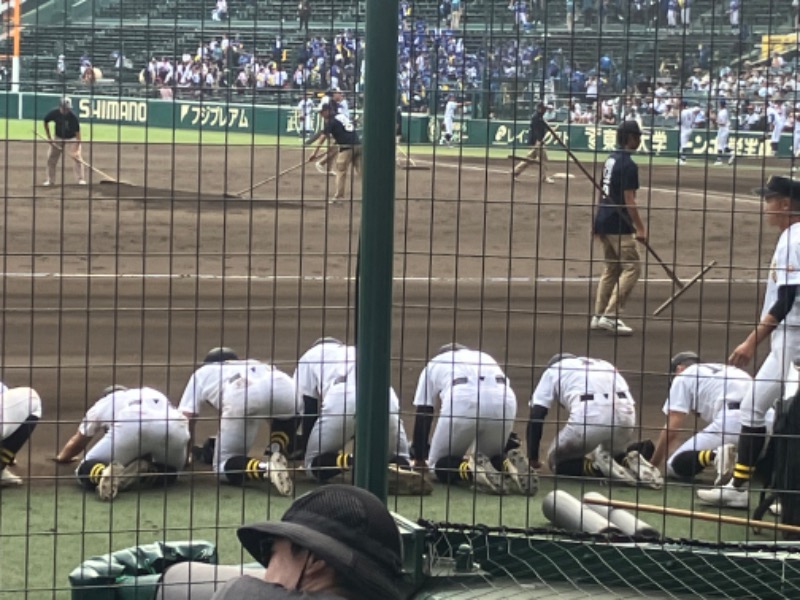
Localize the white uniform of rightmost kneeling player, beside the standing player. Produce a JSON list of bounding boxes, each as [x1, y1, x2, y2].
[[663, 363, 753, 477]]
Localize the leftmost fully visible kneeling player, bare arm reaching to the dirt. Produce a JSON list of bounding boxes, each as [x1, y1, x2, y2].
[[55, 386, 189, 500]]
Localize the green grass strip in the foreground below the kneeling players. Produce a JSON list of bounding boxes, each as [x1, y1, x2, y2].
[[0, 473, 775, 600]]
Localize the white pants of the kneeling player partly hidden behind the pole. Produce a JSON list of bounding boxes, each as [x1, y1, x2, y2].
[[304, 377, 409, 479]]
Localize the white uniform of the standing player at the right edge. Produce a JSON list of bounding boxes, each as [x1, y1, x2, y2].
[[741, 223, 800, 427]]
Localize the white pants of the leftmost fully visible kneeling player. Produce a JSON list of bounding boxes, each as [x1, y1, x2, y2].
[[83, 405, 189, 468]]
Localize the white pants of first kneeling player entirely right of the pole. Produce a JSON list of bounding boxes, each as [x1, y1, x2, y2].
[[428, 377, 517, 466]]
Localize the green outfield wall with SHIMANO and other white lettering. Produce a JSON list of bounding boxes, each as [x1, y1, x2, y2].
[[0, 93, 792, 157]]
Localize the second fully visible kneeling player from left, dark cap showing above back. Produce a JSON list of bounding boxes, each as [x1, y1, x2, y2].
[[179, 348, 297, 496]]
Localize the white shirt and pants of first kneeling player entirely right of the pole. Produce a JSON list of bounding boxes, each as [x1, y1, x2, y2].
[[414, 348, 517, 466]]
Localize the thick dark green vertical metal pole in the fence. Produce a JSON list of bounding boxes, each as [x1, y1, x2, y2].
[[355, 0, 398, 500]]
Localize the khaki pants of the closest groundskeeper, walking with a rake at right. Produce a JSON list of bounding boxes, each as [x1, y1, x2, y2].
[[594, 234, 642, 318]]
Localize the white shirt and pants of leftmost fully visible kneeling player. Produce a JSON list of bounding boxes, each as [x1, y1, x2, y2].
[[81, 387, 189, 468]]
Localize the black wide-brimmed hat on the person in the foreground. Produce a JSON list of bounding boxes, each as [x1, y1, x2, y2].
[[237, 484, 403, 600]]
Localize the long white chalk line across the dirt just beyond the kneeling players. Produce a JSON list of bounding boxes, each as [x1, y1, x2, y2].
[[0, 272, 765, 285]]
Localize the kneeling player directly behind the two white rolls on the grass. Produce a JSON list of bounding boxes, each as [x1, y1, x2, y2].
[[527, 353, 664, 489]]
